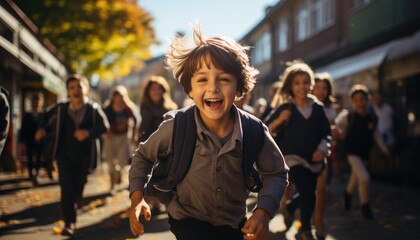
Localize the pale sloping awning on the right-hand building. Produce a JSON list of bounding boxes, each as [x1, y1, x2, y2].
[[315, 40, 397, 80]]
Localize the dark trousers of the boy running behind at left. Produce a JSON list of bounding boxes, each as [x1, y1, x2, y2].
[[57, 156, 89, 224]]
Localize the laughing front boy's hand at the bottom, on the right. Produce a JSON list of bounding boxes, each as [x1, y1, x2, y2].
[[241, 208, 270, 240]]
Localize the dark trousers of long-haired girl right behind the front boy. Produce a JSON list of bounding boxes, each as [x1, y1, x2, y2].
[[286, 165, 318, 231]]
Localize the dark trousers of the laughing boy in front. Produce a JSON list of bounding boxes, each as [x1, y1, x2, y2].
[[169, 216, 246, 240]]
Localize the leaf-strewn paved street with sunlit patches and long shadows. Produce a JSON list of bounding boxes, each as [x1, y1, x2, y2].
[[0, 163, 420, 240]]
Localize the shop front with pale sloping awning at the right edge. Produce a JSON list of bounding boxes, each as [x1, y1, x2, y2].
[[315, 32, 420, 185]]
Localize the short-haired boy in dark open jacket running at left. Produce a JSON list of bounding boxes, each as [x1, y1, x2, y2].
[[35, 74, 109, 236]]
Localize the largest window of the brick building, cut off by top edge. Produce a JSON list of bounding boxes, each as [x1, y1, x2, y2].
[[296, 0, 334, 42]]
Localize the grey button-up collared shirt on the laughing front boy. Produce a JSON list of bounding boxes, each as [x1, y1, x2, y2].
[[129, 107, 289, 228]]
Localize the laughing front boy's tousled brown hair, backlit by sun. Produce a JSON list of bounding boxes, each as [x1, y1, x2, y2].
[[166, 26, 258, 98]]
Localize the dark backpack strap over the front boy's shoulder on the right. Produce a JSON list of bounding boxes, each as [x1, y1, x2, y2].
[[238, 109, 264, 192]]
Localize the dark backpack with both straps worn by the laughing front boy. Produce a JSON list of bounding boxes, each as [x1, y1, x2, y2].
[[145, 105, 264, 204]]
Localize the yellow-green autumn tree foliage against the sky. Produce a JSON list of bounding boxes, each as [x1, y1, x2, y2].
[[15, 0, 157, 80]]
